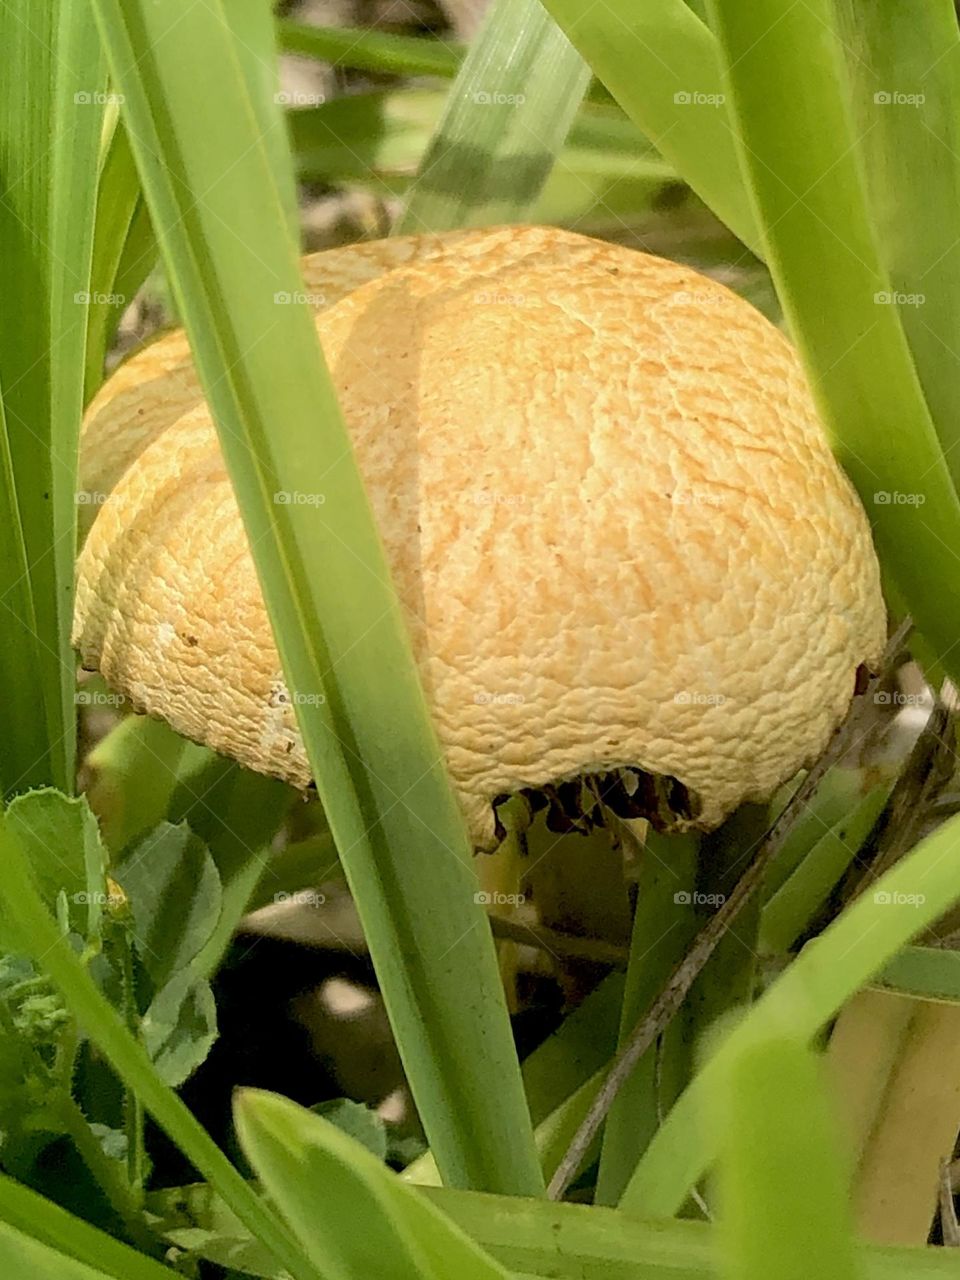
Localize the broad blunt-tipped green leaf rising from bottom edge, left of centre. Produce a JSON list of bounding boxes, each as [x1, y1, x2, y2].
[[236, 1089, 507, 1280]]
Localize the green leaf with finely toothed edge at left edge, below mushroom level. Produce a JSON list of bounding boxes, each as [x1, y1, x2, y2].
[[6, 787, 106, 938]]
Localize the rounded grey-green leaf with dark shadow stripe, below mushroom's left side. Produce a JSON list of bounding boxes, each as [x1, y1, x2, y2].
[[114, 822, 223, 991]]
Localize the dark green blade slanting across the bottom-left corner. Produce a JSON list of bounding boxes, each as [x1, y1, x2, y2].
[[0, 1175, 178, 1280]]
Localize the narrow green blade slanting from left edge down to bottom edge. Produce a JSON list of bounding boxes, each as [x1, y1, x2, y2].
[[0, 818, 320, 1280]]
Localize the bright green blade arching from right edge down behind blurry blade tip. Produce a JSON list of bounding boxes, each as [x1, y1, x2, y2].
[[620, 818, 960, 1217]]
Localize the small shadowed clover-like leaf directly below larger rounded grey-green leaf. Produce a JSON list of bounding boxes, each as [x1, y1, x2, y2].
[[141, 969, 216, 1089]]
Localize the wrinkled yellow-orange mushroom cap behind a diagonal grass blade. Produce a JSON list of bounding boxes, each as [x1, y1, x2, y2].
[[74, 227, 886, 847]]
